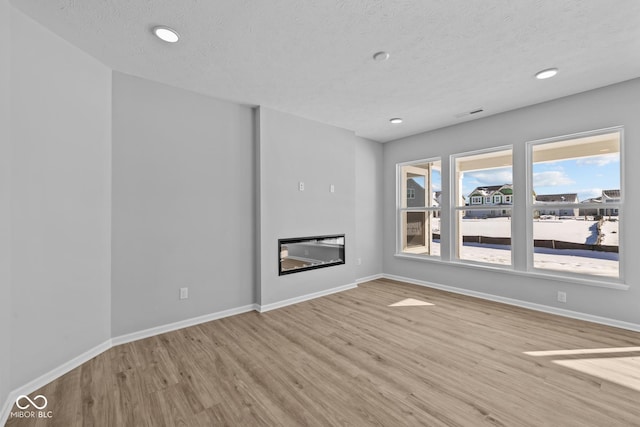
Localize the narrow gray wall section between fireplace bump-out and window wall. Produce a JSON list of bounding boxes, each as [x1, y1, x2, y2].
[[355, 139, 384, 279]]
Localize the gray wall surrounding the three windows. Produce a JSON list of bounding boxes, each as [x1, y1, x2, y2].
[[384, 79, 640, 324]]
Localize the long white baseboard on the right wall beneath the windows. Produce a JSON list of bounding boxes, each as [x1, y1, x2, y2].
[[382, 274, 640, 332]]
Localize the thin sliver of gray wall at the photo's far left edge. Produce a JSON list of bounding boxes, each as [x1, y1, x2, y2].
[[0, 0, 11, 411]]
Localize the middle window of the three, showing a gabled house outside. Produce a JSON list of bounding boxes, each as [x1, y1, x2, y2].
[[452, 147, 513, 265]]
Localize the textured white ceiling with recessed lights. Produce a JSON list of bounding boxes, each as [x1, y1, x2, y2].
[[8, 0, 640, 142]]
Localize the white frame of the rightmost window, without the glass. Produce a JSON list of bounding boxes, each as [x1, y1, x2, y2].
[[525, 126, 626, 284]]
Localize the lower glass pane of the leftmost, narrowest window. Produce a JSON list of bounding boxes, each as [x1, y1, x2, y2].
[[402, 210, 440, 256]]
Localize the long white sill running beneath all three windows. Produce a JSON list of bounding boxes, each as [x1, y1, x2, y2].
[[394, 253, 629, 291]]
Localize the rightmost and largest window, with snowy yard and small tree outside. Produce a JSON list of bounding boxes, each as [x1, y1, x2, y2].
[[528, 129, 623, 278]]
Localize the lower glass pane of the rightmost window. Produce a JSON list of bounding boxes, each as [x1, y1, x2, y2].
[[533, 216, 620, 277]]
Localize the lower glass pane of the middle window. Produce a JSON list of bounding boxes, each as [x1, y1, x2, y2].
[[458, 208, 511, 265]]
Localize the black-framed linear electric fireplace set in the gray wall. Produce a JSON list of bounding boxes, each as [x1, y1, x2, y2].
[[278, 234, 344, 276]]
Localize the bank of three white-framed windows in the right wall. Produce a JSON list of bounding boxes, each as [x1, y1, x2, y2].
[[396, 127, 627, 288]]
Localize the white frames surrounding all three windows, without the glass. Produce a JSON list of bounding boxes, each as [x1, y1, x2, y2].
[[394, 126, 630, 290]]
